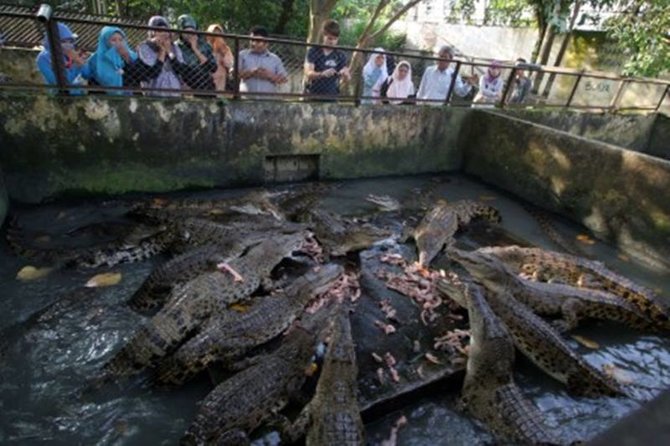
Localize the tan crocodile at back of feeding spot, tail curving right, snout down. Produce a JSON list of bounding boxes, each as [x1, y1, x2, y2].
[[406, 200, 501, 267]]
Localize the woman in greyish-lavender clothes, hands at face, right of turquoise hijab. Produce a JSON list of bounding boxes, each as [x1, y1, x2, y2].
[[126, 15, 184, 96]]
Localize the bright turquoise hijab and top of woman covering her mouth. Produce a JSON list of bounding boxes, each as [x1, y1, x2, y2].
[[89, 26, 137, 94]]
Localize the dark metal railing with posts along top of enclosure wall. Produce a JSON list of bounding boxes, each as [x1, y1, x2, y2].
[[0, 4, 670, 111]]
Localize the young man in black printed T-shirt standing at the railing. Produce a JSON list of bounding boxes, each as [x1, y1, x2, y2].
[[305, 20, 351, 100]]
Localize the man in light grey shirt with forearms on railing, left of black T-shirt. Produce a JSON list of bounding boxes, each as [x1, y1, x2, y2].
[[239, 26, 288, 93]]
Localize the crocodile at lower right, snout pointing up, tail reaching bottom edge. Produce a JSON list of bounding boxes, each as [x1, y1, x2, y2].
[[462, 284, 560, 445]]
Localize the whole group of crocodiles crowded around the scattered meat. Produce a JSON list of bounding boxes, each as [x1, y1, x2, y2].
[[8, 183, 670, 445]]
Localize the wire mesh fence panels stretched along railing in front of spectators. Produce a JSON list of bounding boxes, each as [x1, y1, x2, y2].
[[0, 9, 668, 109]]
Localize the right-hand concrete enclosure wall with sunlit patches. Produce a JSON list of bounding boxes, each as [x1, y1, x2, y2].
[[464, 110, 670, 270]]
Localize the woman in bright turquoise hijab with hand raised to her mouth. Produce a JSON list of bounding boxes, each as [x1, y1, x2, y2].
[[84, 26, 137, 95]]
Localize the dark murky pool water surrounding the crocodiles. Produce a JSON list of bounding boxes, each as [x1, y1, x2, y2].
[[0, 176, 670, 445]]
